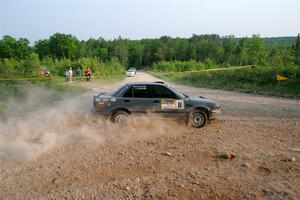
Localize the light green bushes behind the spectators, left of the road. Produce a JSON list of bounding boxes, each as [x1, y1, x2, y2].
[[0, 56, 125, 77]]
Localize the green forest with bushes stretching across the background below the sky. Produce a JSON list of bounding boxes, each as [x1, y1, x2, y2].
[[0, 33, 300, 77]]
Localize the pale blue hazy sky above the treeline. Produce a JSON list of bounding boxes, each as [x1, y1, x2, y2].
[[0, 0, 300, 42]]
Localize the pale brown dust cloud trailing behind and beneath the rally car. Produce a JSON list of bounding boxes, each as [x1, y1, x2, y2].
[[0, 86, 183, 161]]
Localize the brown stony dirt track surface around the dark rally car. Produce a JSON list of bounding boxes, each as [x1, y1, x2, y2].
[[0, 72, 300, 199]]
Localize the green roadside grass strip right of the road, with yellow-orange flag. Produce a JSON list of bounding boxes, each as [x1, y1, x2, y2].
[[150, 66, 300, 98]]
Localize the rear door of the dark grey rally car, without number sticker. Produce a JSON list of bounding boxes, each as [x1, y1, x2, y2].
[[120, 85, 153, 114]]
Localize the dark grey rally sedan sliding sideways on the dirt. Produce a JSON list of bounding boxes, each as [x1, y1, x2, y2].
[[93, 82, 221, 128]]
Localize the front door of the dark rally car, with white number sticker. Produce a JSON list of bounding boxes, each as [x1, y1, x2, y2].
[[150, 85, 186, 117]]
